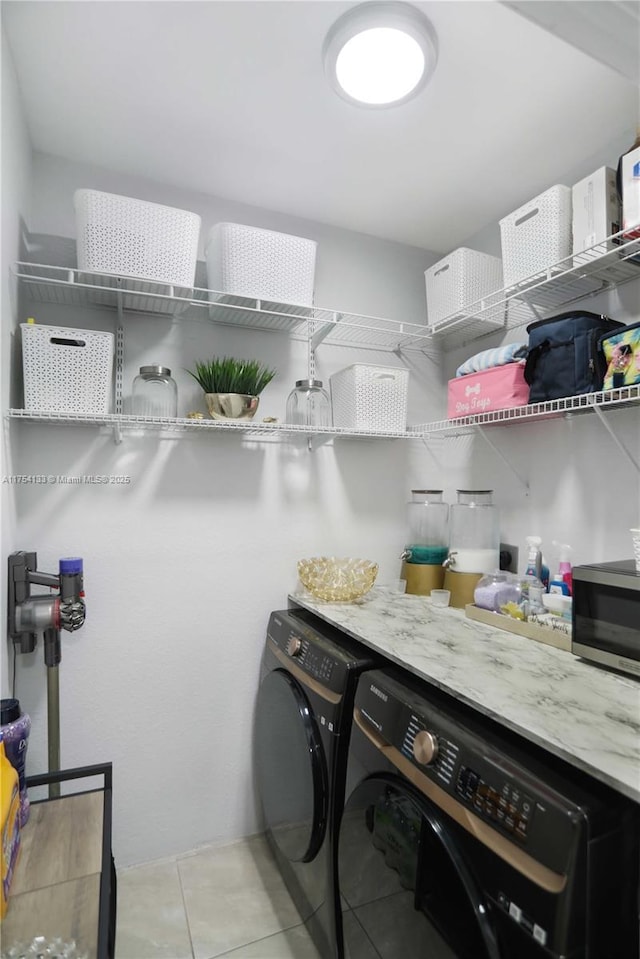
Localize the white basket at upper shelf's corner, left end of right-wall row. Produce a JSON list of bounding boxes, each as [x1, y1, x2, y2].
[[424, 246, 502, 326]]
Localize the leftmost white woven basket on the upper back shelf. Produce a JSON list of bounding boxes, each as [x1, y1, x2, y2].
[[73, 190, 200, 288]]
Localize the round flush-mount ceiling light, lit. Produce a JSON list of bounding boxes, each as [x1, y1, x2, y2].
[[322, 0, 437, 107]]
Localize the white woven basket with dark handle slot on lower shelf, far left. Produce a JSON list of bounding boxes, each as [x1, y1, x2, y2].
[[20, 323, 114, 413]]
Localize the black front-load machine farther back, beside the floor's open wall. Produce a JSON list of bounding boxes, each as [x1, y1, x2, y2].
[[254, 609, 377, 959]]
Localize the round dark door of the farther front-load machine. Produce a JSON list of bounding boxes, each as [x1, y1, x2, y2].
[[254, 669, 328, 862]]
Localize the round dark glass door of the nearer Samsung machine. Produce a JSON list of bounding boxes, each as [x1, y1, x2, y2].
[[338, 773, 500, 959]]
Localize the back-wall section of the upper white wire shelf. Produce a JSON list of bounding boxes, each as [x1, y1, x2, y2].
[[14, 262, 433, 352]]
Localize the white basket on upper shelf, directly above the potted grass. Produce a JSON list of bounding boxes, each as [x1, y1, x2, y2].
[[205, 223, 317, 306]]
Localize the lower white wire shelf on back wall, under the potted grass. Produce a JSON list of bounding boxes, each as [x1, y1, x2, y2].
[[7, 409, 421, 440]]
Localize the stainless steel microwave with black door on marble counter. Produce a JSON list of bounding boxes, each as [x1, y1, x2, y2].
[[571, 559, 640, 679]]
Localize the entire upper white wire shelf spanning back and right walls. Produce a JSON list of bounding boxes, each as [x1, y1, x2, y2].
[[14, 233, 640, 353]]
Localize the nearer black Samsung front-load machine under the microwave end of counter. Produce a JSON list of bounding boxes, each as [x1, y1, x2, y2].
[[338, 667, 639, 959]]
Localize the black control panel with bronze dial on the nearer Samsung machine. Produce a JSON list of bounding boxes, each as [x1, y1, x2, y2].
[[355, 670, 584, 873]]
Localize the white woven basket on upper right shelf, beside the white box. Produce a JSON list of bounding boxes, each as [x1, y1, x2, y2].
[[500, 184, 572, 286]]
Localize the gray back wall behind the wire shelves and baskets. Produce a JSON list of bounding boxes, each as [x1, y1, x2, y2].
[[11, 155, 443, 866]]
